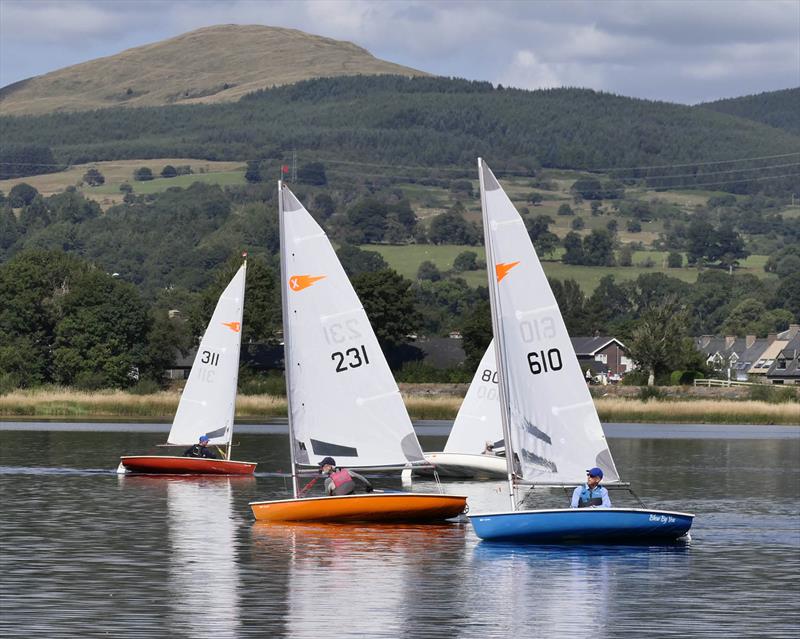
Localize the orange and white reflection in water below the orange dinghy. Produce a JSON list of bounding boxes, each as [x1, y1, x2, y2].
[[253, 522, 466, 637]]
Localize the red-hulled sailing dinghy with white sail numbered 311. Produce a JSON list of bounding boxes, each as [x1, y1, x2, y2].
[[117, 262, 256, 475]]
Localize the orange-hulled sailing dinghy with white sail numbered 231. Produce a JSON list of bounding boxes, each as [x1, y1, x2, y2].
[[250, 183, 466, 522]]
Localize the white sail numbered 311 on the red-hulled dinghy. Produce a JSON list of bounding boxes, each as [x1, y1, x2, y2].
[[167, 264, 246, 446]]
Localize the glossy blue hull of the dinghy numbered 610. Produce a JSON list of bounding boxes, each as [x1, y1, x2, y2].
[[468, 508, 694, 543]]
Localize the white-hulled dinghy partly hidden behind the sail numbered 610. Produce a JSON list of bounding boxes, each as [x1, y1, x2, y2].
[[414, 342, 506, 479]]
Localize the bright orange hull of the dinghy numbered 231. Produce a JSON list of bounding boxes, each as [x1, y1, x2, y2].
[[250, 492, 467, 522]]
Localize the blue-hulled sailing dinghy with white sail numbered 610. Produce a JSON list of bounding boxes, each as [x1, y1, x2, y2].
[[468, 159, 694, 543]]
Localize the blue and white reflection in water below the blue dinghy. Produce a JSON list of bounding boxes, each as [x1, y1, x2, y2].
[[472, 541, 697, 637]]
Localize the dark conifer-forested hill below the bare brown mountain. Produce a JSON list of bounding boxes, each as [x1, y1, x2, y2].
[[0, 76, 800, 191]]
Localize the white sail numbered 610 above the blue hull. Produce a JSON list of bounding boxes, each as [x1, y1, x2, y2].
[[478, 160, 619, 483]]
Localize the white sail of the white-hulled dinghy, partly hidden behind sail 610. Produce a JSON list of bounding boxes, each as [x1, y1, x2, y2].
[[444, 340, 504, 455]]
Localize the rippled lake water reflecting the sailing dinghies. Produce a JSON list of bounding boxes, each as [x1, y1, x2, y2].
[[0, 424, 800, 639]]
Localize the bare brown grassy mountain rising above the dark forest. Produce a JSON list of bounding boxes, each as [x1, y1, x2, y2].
[[0, 24, 427, 115]]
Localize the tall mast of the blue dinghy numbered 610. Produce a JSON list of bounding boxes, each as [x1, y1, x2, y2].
[[478, 158, 517, 510]]
